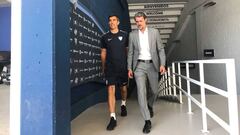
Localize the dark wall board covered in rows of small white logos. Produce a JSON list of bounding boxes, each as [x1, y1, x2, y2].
[[69, 2, 103, 87]]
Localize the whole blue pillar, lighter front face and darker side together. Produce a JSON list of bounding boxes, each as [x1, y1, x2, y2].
[[21, 0, 71, 135]]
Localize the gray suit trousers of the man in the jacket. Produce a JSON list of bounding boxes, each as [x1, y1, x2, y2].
[[134, 62, 158, 120]]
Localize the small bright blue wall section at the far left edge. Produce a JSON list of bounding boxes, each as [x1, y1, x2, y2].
[[0, 7, 11, 51]]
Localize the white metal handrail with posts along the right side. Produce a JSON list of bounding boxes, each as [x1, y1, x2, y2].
[[159, 59, 239, 135]]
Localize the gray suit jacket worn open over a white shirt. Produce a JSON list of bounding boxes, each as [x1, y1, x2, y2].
[[128, 27, 166, 72]]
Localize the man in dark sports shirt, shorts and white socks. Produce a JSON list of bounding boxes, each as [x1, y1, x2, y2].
[[101, 15, 128, 130]]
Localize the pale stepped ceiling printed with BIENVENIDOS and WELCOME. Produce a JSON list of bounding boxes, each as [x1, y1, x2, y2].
[[128, 0, 187, 44]]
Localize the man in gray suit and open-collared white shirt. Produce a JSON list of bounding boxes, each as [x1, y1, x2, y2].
[[128, 12, 166, 133]]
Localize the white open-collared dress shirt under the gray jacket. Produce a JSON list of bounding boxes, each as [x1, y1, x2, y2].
[[138, 28, 151, 60]]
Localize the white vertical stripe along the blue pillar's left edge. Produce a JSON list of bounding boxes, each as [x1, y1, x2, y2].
[[9, 0, 22, 135]]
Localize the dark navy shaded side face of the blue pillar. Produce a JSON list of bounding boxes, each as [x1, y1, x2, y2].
[[53, 0, 71, 135]]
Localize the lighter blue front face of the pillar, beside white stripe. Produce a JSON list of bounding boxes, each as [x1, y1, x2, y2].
[[21, 0, 54, 135]]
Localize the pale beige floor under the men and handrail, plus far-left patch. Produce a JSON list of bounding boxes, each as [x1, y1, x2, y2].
[[0, 85, 239, 135]]
